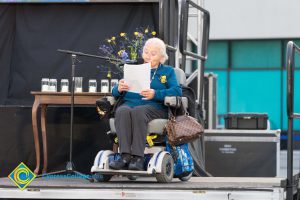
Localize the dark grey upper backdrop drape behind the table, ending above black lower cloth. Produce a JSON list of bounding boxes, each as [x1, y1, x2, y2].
[[0, 3, 158, 105]]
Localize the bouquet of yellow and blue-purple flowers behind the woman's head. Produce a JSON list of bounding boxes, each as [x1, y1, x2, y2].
[[99, 27, 156, 65]]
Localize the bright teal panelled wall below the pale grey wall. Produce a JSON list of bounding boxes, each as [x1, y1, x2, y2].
[[205, 39, 300, 130]]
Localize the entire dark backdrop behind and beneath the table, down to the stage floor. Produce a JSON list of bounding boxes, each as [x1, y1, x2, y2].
[[0, 2, 159, 177]]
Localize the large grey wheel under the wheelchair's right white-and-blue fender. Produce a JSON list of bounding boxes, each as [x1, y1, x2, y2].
[[155, 154, 174, 183]]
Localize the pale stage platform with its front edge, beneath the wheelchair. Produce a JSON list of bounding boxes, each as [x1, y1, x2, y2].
[[0, 177, 285, 200]]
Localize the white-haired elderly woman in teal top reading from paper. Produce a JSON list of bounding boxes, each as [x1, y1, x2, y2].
[[110, 38, 182, 170]]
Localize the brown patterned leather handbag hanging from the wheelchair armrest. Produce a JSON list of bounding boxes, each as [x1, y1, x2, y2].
[[165, 97, 204, 146]]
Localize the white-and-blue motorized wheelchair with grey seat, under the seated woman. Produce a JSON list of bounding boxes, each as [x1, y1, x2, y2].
[[91, 68, 193, 183]]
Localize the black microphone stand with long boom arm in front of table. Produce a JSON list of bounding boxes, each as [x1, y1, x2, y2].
[[38, 49, 137, 181]]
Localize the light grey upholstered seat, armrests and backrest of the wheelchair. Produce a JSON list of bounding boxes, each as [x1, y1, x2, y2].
[[109, 68, 187, 135]]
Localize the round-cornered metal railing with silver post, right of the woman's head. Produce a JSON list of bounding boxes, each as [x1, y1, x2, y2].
[[179, 0, 210, 112]]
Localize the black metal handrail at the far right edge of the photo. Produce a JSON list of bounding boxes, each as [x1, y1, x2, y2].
[[286, 41, 300, 200]]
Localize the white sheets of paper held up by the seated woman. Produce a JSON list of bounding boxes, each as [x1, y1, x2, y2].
[[124, 63, 150, 93]]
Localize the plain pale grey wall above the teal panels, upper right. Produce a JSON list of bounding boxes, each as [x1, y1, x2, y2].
[[204, 0, 300, 39]]
